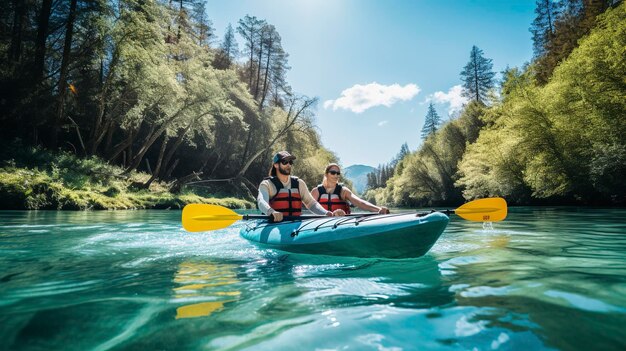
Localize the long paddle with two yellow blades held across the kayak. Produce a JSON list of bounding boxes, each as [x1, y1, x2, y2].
[[182, 197, 507, 232]]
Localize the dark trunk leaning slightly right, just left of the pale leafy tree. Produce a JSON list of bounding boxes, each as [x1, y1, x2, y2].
[[51, 0, 76, 149]]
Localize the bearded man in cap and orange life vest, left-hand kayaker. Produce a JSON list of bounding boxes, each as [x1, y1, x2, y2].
[[257, 151, 333, 222]]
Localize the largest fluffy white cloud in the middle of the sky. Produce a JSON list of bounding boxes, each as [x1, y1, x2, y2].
[[324, 82, 420, 113]]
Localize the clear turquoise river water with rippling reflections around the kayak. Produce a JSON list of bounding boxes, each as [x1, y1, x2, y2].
[[0, 208, 626, 351]]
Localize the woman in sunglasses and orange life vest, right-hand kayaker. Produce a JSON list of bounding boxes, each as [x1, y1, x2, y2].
[[311, 163, 389, 216]]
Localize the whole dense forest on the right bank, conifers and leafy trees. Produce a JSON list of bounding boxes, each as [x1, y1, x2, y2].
[[366, 0, 626, 206]]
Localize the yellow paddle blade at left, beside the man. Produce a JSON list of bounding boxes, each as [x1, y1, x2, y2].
[[182, 204, 243, 232]]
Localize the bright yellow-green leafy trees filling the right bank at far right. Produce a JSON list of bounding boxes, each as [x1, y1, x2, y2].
[[457, 4, 626, 203]]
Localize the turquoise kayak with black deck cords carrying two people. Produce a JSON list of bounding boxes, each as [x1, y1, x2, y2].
[[240, 212, 449, 258]]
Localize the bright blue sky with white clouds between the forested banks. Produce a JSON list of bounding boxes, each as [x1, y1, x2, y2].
[[206, 0, 535, 167]]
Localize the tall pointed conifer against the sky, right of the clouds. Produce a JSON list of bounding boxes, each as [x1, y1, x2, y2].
[[461, 46, 496, 104]]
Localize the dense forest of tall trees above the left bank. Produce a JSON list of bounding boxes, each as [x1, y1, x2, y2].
[[0, 0, 336, 206]]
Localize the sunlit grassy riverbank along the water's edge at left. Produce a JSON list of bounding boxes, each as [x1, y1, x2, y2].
[[0, 145, 255, 210]]
